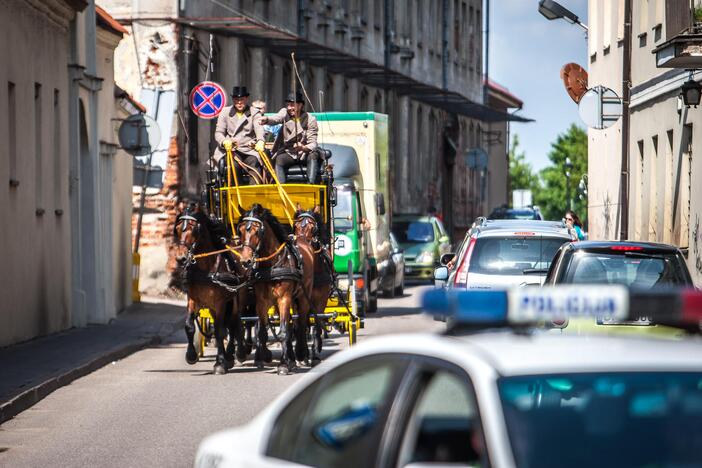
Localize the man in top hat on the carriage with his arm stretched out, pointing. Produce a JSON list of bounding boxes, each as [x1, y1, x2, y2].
[[261, 93, 319, 184]]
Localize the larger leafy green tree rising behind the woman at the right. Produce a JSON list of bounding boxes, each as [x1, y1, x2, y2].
[[534, 124, 587, 222]]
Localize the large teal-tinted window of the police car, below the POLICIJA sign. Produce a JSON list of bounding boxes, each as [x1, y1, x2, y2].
[[498, 372, 702, 468]]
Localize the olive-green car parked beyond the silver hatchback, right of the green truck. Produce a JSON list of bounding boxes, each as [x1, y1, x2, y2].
[[392, 215, 450, 280]]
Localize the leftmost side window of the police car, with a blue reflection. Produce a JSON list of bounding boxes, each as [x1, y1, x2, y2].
[[267, 355, 407, 467]]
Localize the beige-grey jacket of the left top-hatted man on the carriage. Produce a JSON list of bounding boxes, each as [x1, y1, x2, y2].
[[214, 106, 263, 161]]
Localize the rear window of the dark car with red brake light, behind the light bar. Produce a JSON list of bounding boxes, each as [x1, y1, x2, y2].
[[560, 251, 688, 289]]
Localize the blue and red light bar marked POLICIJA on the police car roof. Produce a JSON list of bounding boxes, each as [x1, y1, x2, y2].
[[423, 285, 702, 330]]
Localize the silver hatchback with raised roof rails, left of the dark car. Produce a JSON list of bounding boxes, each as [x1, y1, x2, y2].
[[434, 218, 577, 289]]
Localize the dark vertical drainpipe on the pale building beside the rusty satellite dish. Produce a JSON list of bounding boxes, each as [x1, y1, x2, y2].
[[619, 0, 632, 240]]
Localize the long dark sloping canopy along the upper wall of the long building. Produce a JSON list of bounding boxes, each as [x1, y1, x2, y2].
[[177, 15, 533, 122]]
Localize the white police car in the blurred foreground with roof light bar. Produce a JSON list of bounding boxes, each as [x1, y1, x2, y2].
[[195, 286, 702, 468]]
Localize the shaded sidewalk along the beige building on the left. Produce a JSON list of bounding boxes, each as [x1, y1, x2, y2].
[[0, 299, 185, 424]]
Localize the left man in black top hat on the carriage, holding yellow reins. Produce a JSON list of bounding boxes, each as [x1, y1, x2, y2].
[[214, 86, 264, 185]]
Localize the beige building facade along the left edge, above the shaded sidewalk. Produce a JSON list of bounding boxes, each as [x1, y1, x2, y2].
[[0, 0, 131, 346]]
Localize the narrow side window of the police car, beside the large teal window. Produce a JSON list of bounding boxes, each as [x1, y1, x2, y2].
[[398, 370, 487, 466]]
